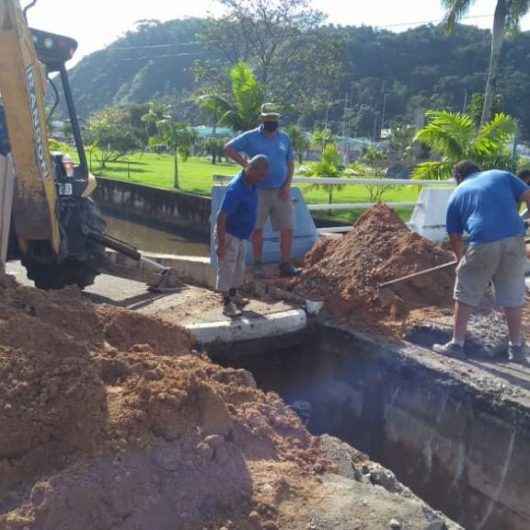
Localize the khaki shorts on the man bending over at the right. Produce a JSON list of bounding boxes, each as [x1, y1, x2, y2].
[[454, 236, 527, 308]]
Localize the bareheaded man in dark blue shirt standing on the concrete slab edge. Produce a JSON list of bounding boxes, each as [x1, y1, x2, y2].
[[215, 155, 269, 317]]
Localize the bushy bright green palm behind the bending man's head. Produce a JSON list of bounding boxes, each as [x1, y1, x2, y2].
[[413, 111, 517, 180]]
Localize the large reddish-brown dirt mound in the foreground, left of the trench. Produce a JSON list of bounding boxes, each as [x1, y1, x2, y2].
[[0, 277, 325, 530]]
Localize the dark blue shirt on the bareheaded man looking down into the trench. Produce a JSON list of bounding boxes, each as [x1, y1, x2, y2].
[[220, 171, 258, 239]]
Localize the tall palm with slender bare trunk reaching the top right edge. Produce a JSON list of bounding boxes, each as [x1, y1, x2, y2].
[[442, 0, 530, 125]]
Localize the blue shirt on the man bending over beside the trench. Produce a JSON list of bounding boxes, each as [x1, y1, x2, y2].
[[447, 169, 529, 244]]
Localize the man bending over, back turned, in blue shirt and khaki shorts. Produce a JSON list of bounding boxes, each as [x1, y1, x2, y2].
[[433, 160, 530, 362]]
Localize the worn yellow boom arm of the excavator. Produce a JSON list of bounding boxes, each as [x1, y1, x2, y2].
[[0, 0, 60, 253]]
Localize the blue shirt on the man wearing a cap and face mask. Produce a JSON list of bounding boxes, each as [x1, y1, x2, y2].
[[228, 125, 294, 189]]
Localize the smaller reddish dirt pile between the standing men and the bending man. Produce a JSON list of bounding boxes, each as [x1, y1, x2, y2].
[[296, 204, 454, 319]]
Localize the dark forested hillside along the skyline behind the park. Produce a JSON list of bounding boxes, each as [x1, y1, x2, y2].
[[68, 19, 530, 137]]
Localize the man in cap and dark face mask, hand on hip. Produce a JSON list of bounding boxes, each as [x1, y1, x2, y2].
[[225, 104, 299, 277]]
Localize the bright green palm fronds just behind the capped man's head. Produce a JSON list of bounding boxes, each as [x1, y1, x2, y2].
[[197, 62, 265, 131]]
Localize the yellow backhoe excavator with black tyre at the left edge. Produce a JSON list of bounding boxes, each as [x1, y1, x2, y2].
[[0, 0, 175, 290]]
